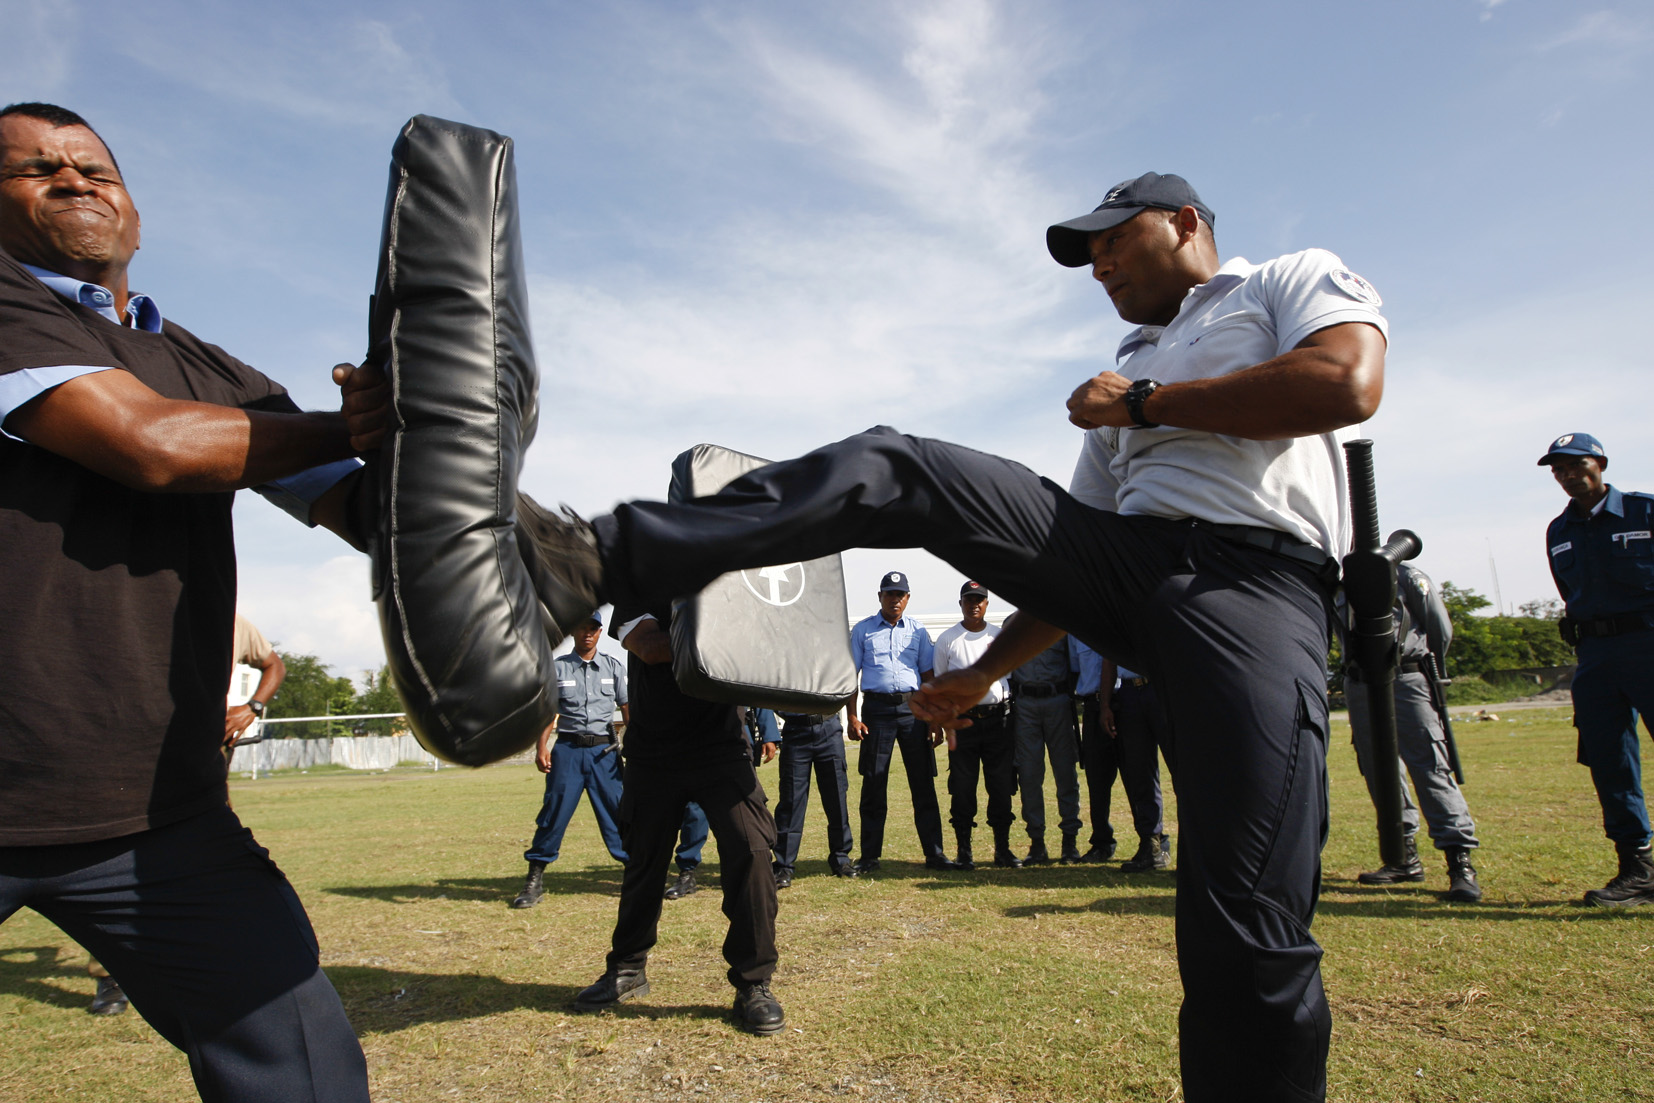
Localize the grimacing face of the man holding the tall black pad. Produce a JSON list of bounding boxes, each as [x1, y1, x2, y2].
[[0, 116, 139, 286]]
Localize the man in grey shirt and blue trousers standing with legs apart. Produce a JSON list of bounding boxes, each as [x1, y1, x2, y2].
[[511, 614, 629, 908]]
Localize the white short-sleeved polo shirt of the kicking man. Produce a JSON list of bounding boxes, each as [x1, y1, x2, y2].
[[1068, 250, 1389, 556]]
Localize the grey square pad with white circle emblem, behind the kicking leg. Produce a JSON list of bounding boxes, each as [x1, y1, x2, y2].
[[667, 445, 857, 713]]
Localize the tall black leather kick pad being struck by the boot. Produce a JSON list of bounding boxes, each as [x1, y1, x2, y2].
[[369, 116, 556, 766]]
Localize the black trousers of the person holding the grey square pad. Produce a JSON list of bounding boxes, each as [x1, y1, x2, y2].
[[609, 754, 776, 986]]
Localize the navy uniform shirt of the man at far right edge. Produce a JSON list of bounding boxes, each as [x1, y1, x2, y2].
[[1545, 486, 1654, 620]]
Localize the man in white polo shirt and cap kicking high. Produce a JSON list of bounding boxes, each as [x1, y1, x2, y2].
[[522, 172, 1386, 1103]]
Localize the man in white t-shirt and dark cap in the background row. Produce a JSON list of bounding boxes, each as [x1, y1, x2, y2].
[[935, 580, 1022, 870]]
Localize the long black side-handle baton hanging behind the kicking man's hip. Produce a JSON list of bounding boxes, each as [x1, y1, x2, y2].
[[1343, 440, 1422, 865]]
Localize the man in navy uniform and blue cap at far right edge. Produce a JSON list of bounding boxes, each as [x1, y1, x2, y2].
[[1540, 433, 1654, 908]]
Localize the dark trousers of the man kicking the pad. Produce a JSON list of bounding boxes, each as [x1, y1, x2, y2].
[[594, 427, 1331, 1103]]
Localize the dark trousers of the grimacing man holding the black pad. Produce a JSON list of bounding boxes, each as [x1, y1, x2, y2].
[[0, 807, 367, 1103]]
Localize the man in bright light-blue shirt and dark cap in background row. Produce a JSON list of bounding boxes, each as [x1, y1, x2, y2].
[[847, 571, 954, 873]]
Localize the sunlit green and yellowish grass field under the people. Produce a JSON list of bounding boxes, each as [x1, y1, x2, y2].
[[0, 709, 1654, 1103]]
